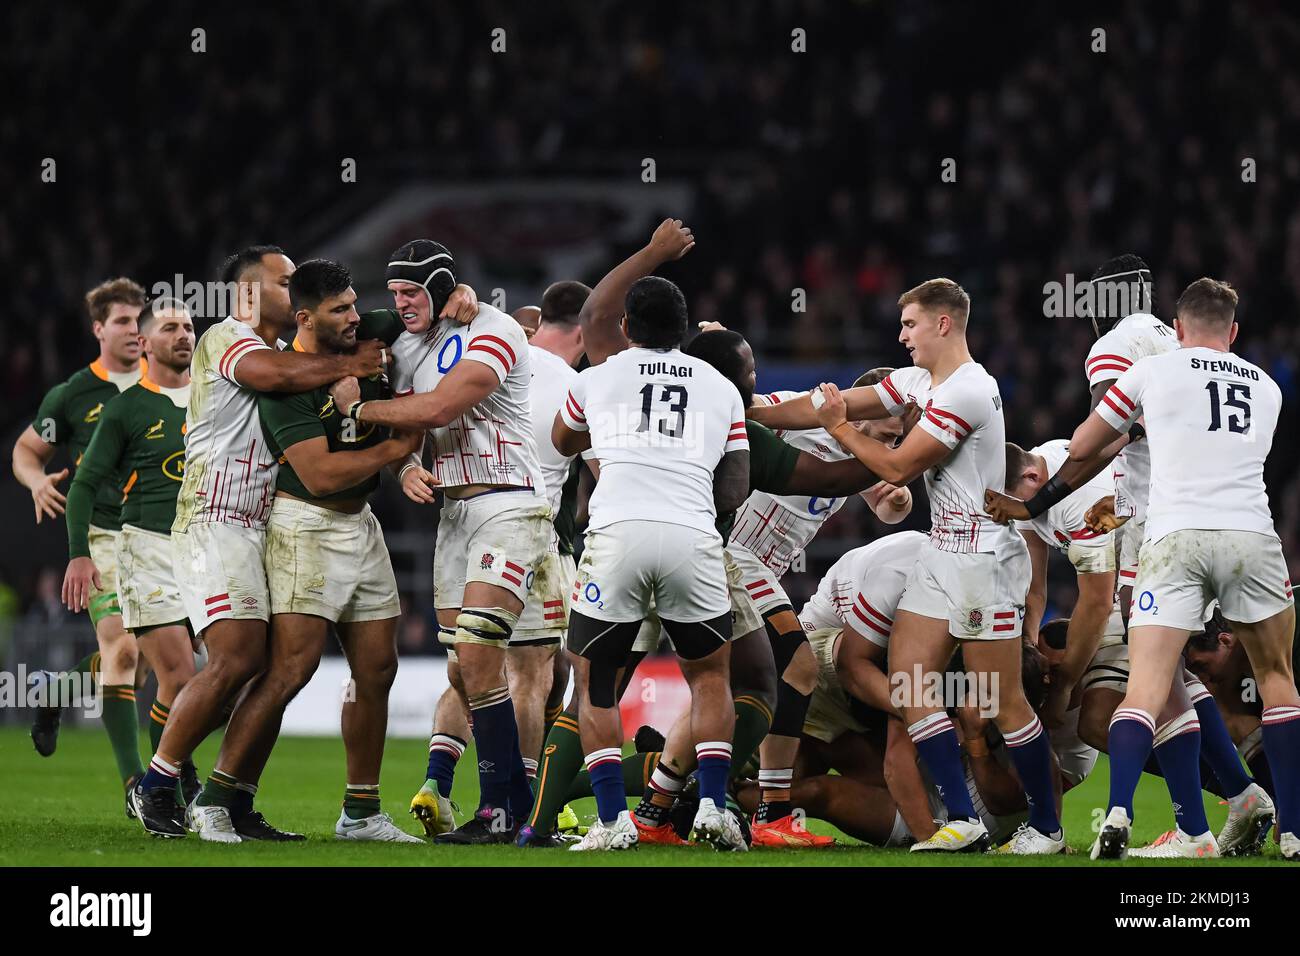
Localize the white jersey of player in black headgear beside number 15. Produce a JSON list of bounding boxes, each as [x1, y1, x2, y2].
[[1084, 312, 1178, 522]]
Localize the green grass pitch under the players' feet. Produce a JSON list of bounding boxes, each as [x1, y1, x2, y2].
[[0, 727, 1281, 866]]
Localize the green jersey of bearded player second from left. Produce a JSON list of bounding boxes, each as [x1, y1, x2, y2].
[[68, 378, 190, 558]]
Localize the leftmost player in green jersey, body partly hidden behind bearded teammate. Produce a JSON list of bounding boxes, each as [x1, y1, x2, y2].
[[13, 278, 144, 806]]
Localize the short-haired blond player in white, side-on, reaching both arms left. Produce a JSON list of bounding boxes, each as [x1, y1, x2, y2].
[[753, 278, 1065, 853]]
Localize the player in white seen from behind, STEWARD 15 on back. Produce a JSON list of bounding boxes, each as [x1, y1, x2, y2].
[[1070, 278, 1300, 858]]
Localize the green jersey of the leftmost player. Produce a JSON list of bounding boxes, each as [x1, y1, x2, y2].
[[31, 359, 147, 531]]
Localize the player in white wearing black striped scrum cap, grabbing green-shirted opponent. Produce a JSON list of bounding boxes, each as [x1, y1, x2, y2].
[[334, 239, 553, 844]]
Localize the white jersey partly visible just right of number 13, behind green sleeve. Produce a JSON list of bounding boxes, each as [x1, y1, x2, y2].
[[728, 392, 853, 578]]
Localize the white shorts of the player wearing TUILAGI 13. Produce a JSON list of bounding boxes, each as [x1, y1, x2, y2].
[[571, 520, 731, 624]]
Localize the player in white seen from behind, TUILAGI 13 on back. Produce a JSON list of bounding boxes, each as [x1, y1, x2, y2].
[[554, 276, 749, 849]]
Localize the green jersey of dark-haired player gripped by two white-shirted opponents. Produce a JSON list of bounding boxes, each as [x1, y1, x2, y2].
[[257, 308, 406, 503]]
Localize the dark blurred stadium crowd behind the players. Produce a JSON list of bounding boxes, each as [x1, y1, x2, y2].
[[0, 0, 1300, 648]]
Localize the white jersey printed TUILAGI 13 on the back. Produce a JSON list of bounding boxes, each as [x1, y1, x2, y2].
[[560, 349, 749, 535]]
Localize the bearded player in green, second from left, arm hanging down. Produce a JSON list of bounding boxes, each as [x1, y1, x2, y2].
[[64, 299, 199, 803]]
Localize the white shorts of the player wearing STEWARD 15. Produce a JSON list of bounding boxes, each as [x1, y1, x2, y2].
[[1128, 531, 1292, 632]]
